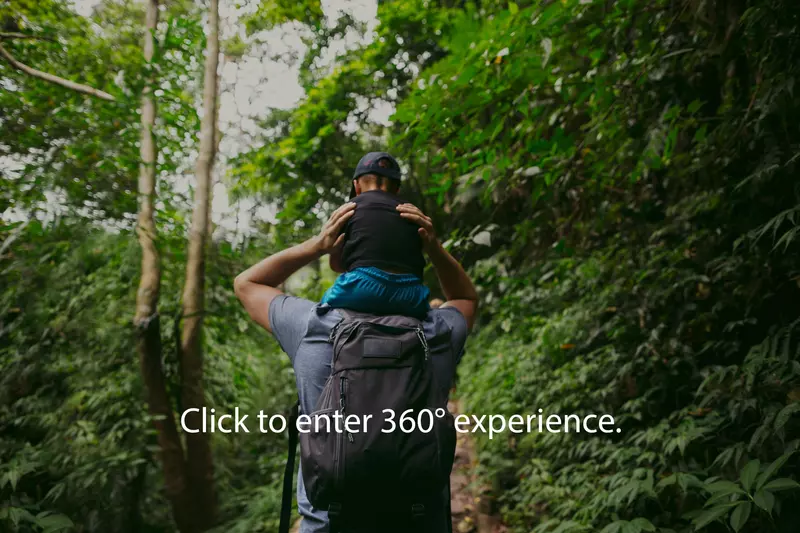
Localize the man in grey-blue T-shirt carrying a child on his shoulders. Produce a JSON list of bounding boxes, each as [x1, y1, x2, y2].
[[234, 196, 478, 533]]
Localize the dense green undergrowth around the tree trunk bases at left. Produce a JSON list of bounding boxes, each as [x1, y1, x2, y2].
[[0, 222, 294, 532]]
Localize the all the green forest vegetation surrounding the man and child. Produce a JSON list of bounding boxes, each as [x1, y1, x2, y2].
[[0, 0, 800, 533]]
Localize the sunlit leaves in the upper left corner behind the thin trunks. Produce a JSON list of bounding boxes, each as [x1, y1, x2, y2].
[[0, 0, 203, 220]]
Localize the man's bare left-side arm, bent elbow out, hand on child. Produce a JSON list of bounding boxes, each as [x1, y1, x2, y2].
[[233, 203, 355, 332]]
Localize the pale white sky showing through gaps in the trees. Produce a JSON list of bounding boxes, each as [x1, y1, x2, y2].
[[0, 0, 394, 239]]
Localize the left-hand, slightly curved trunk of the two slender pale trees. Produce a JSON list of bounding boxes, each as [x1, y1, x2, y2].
[[134, 0, 194, 533]]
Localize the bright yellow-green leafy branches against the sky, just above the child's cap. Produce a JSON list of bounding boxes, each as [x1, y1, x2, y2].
[[231, 0, 454, 243]]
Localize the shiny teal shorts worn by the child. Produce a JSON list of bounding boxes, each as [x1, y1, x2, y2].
[[321, 267, 431, 319]]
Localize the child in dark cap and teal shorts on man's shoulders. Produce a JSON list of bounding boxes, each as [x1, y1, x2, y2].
[[321, 152, 430, 319]]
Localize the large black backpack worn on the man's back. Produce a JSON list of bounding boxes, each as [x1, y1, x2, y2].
[[280, 310, 456, 533]]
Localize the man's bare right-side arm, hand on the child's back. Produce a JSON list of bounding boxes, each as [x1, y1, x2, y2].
[[397, 204, 478, 329]]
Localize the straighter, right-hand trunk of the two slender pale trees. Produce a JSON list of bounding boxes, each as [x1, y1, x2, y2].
[[181, 0, 219, 531]]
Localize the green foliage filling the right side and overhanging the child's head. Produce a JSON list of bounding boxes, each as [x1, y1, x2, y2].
[[234, 0, 800, 532]]
